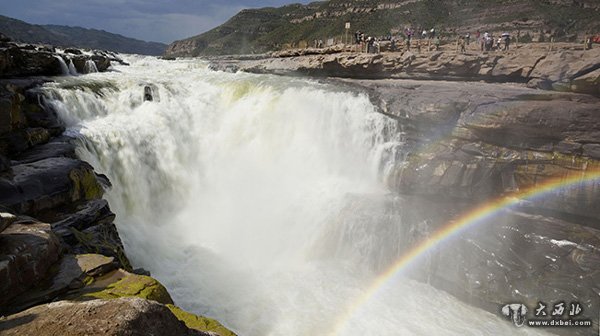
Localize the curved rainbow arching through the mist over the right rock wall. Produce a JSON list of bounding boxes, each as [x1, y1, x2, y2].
[[332, 170, 600, 335]]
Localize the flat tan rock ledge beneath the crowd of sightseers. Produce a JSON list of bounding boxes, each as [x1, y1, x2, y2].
[[210, 43, 600, 96]]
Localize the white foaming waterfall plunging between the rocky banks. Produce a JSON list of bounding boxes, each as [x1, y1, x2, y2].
[[45, 56, 548, 336]]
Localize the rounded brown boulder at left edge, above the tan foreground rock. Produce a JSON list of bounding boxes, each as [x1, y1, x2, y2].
[[0, 219, 60, 307]]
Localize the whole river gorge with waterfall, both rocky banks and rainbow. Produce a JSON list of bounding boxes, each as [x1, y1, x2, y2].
[[0, 28, 600, 336]]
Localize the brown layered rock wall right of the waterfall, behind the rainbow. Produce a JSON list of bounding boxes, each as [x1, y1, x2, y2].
[[345, 80, 600, 335]]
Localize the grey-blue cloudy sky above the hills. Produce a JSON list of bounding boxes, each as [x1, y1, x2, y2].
[[0, 0, 311, 43]]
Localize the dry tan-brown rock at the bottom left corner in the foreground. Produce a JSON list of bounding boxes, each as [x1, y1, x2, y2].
[[0, 298, 210, 336]]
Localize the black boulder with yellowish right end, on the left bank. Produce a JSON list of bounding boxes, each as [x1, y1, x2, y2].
[[0, 158, 103, 214]]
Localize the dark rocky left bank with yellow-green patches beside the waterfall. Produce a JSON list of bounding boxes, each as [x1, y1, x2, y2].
[[0, 41, 234, 336]]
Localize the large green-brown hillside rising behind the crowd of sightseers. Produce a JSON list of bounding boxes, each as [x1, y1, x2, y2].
[[166, 0, 600, 56]]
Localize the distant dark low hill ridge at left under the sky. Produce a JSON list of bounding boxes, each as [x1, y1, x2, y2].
[[0, 15, 166, 55]]
